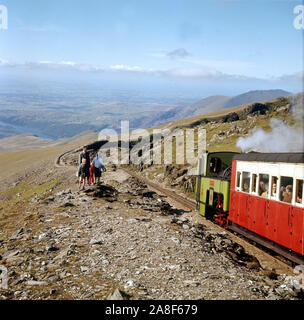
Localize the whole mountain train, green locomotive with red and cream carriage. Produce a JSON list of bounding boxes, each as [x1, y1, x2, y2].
[[196, 151, 304, 264]]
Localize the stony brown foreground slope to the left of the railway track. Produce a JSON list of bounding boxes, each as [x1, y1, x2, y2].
[[0, 164, 300, 299]]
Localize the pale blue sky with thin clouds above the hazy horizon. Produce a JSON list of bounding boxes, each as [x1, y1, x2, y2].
[[0, 0, 304, 95]]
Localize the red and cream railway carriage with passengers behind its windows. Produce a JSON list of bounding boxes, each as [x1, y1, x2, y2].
[[228, 152, 304, 257]]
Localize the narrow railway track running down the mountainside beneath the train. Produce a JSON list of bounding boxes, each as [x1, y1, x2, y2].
[[55, 150, 298, 274]]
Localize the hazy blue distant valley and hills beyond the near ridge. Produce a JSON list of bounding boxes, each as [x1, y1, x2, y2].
[[0, 86, 290, 150]]
